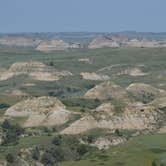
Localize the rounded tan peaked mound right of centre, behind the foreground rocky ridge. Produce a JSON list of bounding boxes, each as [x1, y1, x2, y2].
[[84, 81, 129, 101]]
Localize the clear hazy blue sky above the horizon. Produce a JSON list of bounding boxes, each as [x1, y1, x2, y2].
[[0, 0, 166, 33]]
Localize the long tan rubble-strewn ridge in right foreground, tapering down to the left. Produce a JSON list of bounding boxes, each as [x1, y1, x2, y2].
[[62, 104, 165, 134]]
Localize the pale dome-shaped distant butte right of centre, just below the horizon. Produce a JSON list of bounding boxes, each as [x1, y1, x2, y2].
[[88, 37, 120, 49]]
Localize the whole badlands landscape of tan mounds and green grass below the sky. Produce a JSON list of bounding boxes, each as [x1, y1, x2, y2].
[[0, 33, 166, 166]]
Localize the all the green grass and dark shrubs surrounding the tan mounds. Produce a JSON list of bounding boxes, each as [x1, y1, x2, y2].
[[0, 45, 166, 166]]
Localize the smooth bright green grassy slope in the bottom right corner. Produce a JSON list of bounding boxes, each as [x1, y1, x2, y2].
[[62, 134, 166, 166]]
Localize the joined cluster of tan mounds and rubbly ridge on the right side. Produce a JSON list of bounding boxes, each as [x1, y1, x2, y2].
[[62, 81, 166, 134]]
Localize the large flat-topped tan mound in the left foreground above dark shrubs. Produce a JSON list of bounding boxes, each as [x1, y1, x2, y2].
[[5, 97, 72, 127]]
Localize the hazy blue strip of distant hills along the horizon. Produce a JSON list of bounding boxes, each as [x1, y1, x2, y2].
[[0, 31, 166, 42]]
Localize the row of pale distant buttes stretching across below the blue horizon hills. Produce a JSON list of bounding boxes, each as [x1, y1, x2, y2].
[[0, 35, 166, 52]]
